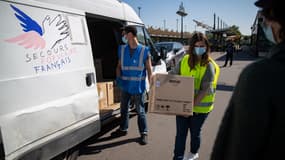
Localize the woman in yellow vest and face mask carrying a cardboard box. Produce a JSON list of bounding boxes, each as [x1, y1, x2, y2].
[[170, 32, 220, 160]]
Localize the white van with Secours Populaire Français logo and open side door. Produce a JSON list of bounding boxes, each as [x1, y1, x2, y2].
[[0, 0, 166, 160]]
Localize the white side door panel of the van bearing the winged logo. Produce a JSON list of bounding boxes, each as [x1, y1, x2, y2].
[[0, 1, 100, 159]]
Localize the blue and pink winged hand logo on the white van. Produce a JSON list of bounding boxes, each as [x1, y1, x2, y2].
[[5, 5, 69, 49]]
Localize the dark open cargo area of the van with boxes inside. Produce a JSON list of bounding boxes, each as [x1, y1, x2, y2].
[[87, 14, 123, 121]]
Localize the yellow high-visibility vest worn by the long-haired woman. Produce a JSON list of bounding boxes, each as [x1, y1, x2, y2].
[[180, 54, 220, 113]]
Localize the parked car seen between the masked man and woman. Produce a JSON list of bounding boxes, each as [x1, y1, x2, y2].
[[155, 42, 186, 71]]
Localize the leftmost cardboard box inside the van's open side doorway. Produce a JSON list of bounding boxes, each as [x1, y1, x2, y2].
[[97, 82, 108, 109]]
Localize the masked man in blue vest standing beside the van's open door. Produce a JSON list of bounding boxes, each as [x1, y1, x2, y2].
[[111, 26, 152, 145]]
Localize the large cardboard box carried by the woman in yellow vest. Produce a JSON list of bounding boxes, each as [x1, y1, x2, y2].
[[150, 74, 194, 115]]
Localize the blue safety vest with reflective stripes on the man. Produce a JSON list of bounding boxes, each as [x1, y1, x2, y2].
[[119, 44, 149, 94]]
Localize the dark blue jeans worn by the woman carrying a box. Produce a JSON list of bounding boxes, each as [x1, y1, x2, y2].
[[173, 113, 208, 160]]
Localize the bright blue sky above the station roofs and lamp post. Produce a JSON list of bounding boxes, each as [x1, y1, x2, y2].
[[123, 0, 258, 35]]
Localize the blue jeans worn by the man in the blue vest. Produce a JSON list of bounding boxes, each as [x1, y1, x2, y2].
[[120, 91, 148, 134]]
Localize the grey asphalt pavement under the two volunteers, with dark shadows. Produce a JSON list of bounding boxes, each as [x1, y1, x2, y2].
[[79, 49, 256, 160]]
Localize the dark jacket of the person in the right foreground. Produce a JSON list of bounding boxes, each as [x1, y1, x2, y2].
[[211, 43, 285, 160]]
